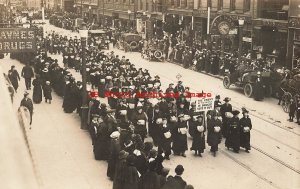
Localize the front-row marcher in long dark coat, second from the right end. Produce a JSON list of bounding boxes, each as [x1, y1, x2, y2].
[[225, 110, 241, 153]]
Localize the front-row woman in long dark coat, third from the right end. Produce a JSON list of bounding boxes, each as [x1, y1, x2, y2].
[[207, 111, 222, 156]]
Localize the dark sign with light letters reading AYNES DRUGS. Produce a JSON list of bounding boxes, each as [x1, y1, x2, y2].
[[0, 28, 36, 53]]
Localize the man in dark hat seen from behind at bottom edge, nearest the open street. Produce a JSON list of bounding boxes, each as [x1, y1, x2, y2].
[[161, 165, 186, 189]]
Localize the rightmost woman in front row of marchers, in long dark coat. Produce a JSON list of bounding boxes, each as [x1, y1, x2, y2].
[[239, 108, 252, 153]]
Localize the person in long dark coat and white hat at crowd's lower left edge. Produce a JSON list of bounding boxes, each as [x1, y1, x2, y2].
[[106, 131, 121, 180]]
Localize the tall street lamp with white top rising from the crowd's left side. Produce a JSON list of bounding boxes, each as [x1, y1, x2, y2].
[[79, 24, 88, 130]]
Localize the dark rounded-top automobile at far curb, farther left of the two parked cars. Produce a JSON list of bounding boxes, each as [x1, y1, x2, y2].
[[116, 33, 142, 52]]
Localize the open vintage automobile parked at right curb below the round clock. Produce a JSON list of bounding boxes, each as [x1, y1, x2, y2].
[[223, 70, 272, 98]]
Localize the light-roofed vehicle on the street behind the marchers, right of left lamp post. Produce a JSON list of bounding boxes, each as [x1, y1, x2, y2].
[[89, 30, 110, 50]]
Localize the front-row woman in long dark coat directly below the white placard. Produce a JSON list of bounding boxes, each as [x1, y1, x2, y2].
[[190, 115, 206, 157]]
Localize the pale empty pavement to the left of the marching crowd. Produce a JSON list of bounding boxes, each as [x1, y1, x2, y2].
[[0, 54, 112, 189]]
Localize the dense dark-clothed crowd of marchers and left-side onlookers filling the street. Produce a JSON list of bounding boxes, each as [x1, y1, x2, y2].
[[5, 24, 252, 189]]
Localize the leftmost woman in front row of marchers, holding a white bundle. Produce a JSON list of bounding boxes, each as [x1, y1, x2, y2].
[[157, 118, 172, 160]]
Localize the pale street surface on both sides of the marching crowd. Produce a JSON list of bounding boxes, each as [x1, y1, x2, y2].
[[0, 21, 300, 189]]
